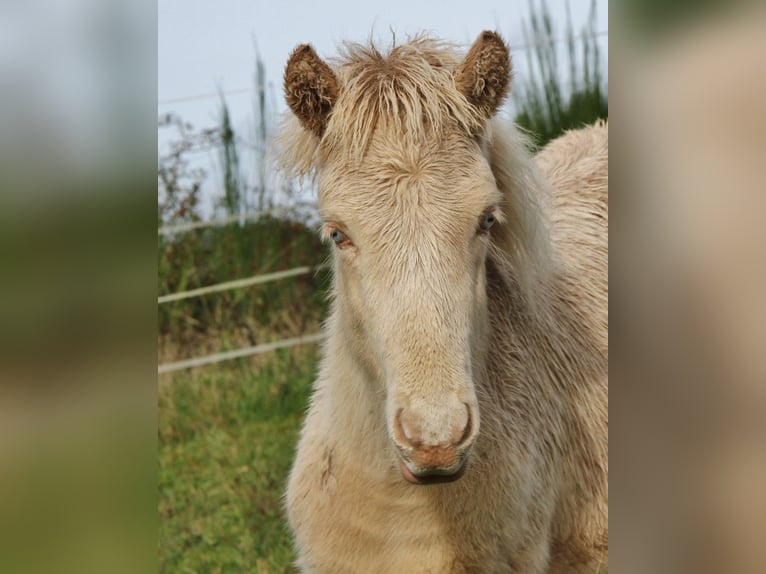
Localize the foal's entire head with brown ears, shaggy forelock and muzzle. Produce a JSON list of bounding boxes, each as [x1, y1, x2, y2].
[[285, 32, 510, 483]]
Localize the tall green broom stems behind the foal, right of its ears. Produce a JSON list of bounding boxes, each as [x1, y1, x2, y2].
[[516, 0, 609, 147]]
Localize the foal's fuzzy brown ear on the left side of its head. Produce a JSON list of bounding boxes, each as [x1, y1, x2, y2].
[[285, 44, 338, 137]]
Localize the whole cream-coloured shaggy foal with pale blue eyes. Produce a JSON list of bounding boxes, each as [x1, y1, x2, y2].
[[277, 31, 608, 574]]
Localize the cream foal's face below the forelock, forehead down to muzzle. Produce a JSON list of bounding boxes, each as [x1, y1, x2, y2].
[[320, 141, 502, 483]]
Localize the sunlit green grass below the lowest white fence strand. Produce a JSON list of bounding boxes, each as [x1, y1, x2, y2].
[[159, 346, 317, 573]]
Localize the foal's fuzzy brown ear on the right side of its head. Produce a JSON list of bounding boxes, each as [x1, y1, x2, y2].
[[455, 31, 511, 118]]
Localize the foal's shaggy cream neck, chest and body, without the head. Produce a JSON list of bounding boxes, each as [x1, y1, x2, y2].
[[285, 33, 608, 573]]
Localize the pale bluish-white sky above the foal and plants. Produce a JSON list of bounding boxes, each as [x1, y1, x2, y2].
[[157, 0, 608, 216]]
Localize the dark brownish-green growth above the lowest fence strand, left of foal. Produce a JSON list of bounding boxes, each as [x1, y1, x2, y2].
[[158, 217, 330, 363]]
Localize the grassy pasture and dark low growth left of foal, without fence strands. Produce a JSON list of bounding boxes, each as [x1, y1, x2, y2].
[[157, 218, 329, 574]]
